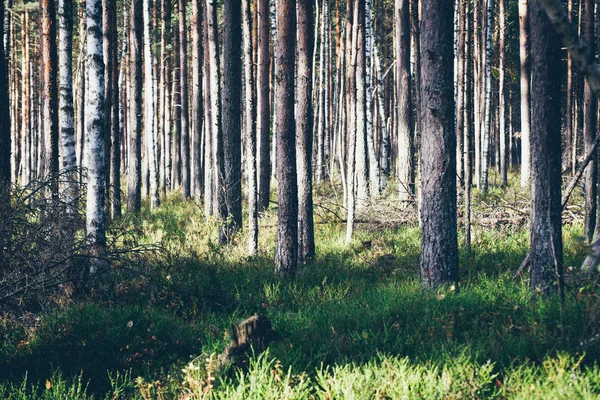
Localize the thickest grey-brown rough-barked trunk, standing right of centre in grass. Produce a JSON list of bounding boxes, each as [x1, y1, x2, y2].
[[420, 0, 458, 287]]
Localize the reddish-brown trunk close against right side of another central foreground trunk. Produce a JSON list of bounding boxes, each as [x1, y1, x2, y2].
[[296, 0, 315, 262]]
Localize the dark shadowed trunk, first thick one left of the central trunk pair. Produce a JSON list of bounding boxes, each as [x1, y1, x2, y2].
[[222, 0, 242, 233]]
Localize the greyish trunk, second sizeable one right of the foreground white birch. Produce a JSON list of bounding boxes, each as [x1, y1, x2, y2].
[[127, 0, 143, 213]]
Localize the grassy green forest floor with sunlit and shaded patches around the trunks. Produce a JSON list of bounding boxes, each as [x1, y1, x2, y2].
[[0, 171, 600, 399]]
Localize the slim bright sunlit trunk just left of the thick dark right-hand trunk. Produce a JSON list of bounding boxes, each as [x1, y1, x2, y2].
[[519, 0, 531, 188]]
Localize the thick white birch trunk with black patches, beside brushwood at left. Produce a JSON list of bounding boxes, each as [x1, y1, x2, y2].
[[85, 0, 106, 268]]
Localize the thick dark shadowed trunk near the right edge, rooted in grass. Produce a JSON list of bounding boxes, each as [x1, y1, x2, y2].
[[530, 0, 563, 292]]
